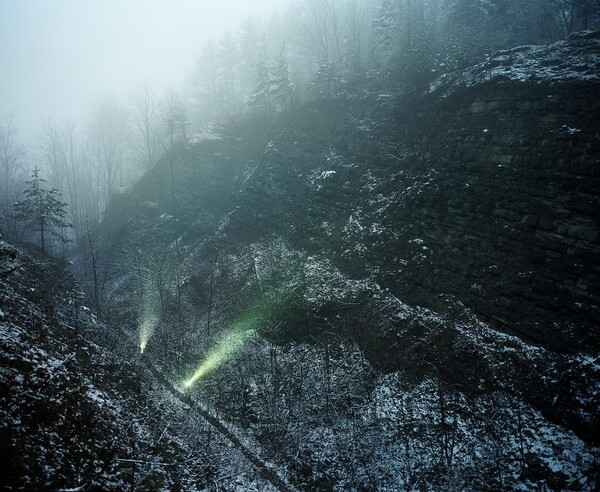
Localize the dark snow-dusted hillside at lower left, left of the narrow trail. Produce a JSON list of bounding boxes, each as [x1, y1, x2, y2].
[[0, 237, 288, 491]]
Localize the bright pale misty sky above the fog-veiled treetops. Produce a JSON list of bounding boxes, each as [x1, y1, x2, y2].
[[0, 0, 285, 143]]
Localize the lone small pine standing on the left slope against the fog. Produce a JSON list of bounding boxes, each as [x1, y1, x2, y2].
[[13, 167, 73, 251]]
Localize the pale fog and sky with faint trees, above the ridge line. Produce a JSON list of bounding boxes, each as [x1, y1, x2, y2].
[[0, 0, 600, 224]]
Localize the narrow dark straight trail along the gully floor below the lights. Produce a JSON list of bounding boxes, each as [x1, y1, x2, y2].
[[136, 357, 296, 492]]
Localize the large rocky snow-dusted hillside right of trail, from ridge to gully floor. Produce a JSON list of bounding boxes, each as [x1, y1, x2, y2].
[[94, 33, 600, 490]]
